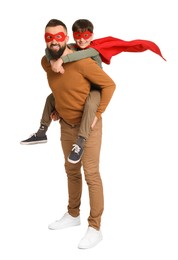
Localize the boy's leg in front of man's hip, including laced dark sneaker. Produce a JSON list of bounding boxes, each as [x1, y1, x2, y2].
[[68, 90, 101, 163]]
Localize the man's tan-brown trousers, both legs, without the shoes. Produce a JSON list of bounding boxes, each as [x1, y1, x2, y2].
[[60, 119, 104, 229]]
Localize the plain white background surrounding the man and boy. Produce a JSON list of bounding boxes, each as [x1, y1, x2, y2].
[[0, 0, 178, 260]]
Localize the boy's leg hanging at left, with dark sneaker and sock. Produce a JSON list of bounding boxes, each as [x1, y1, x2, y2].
[[20, 93, 55, 144]]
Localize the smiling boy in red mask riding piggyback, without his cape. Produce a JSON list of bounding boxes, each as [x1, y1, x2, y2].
[[20, 19, 102, 163]]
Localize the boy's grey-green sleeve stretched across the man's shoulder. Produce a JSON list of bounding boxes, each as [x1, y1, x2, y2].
[[61, 48, 102, 67]]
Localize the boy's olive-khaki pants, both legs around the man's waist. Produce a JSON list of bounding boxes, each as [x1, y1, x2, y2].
[[41, 90, 101, 139]]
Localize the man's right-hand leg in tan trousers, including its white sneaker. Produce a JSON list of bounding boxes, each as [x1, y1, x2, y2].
[[79, 119, 104, 249]]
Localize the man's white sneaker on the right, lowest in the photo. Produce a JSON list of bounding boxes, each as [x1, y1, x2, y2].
[[78, 227, 103, 249]]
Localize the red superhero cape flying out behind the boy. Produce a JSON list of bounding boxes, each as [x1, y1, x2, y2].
[[89, 36, 166, 64]]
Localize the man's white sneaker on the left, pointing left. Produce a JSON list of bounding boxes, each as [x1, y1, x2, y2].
[[48, 213, 80, 230]]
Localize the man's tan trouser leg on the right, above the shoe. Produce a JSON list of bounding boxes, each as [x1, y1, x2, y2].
[[82, 119, 104, 229]]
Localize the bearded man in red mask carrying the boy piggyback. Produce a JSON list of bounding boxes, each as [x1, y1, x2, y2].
[[41, 19, 116, 249]]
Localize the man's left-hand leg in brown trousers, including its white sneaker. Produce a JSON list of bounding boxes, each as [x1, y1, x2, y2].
[[49, 120, 82, 229]]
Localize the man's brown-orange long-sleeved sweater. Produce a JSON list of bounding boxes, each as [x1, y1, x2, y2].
[[41, 56, 116, 124]]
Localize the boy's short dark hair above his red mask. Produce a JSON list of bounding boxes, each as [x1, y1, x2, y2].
[[72, 19, 94, 33]]
